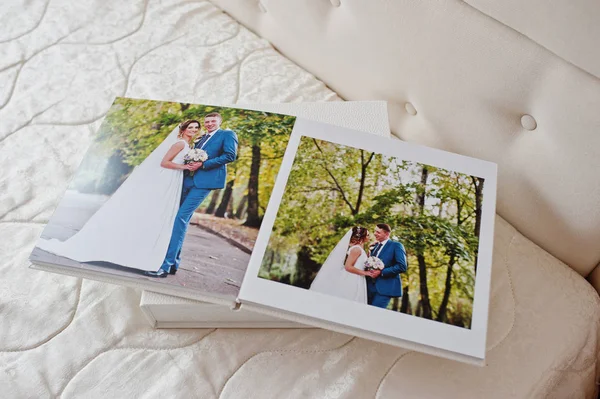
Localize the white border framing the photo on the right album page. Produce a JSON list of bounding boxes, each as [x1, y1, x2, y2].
[[239, 118, 497, 365]]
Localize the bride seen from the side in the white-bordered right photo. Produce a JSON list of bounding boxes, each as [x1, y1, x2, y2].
[[309, 226, 370, 303]]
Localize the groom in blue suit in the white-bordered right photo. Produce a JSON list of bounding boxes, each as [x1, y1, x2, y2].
[[367, 223, 407, 309]]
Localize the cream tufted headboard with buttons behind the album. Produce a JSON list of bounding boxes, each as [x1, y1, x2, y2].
[[213, 0, 600, 282]]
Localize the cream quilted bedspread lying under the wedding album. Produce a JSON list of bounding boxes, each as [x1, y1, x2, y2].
[[0, 0, 600, 398]]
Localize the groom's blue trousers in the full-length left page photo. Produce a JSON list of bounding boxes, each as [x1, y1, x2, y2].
[[160, 176, 211, 272]]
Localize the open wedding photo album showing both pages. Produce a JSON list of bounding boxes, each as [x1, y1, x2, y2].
[[30, 98, 497, 364]]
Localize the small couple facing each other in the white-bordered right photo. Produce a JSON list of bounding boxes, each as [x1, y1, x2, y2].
[[310, 223, 407, 309]]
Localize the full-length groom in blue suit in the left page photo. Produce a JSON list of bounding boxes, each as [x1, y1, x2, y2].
[[146, 112, 238, 277]]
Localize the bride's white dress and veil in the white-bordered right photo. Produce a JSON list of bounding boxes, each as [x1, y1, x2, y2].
[[309, 230, 368, 303]]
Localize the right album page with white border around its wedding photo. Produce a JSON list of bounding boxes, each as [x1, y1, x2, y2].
[[240, 119, 496, 359]]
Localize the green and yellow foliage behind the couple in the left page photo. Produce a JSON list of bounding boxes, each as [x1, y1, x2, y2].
[[74, 98, 295, 219]]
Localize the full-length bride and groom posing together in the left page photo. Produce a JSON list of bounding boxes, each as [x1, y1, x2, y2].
[[38, 112, 238, 277]]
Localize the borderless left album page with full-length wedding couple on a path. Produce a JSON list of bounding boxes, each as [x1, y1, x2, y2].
[[30, 98, 296, 303]]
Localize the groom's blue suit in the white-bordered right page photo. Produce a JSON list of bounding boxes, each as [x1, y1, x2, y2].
[[367, 240, 407, 309]]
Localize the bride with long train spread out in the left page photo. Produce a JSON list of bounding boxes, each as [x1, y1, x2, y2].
[[38, 120, 200, 271]]
